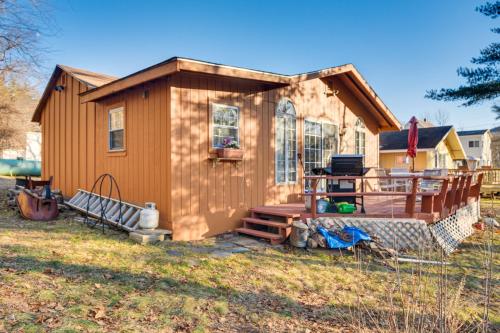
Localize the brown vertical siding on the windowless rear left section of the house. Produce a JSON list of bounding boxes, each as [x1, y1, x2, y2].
[[40, 73, 96, 197]]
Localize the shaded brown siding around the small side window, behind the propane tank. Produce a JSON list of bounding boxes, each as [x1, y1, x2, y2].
[[95, 79, 172, 229]]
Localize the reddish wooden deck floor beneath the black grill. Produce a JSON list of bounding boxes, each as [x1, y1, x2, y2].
[[253, 196, 446, 223]]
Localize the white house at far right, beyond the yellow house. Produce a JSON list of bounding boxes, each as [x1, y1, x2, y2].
[[458, 129, 492, 169]]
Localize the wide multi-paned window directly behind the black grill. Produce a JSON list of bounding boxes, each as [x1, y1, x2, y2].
[[304, 120, 338, 188]]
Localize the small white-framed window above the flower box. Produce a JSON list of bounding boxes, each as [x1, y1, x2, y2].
[[212, 103, 240, 148]]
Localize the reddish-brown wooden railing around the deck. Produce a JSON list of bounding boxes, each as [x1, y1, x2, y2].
[[303, 172, 483, 220]]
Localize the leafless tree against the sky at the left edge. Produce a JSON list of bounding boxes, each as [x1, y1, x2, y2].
[[0, 0, 51, 153]]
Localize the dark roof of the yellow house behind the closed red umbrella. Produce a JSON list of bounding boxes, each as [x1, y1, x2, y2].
[[380, 126, 452, 151]]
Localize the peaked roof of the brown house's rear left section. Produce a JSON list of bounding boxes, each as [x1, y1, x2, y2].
[[31, 65, 117, 122]]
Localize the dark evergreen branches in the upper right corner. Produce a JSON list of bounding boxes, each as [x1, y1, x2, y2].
[[425, 1, 500, 119]]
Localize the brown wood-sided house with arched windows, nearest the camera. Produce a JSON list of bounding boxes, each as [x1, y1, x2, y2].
[[33, 57, 400, 240]]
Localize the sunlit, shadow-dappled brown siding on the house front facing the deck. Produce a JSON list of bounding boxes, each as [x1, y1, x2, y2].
[[170, 73, 379, 239]]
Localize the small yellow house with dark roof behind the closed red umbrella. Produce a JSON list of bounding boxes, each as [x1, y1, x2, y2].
[[380, 126, 466, 171]]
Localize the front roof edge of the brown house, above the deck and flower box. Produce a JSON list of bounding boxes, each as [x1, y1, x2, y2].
[[81, 57, 401, 130]]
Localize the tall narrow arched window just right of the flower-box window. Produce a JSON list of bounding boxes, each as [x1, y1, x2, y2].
[[276, 98, 297, 184]]
